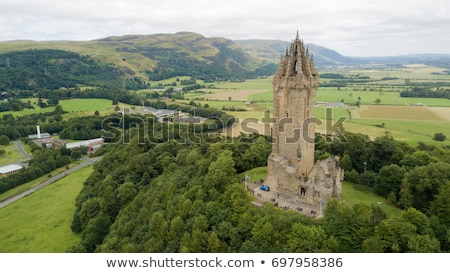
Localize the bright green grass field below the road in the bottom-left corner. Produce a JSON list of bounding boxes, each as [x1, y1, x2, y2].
[[0, 166, 93, 253]]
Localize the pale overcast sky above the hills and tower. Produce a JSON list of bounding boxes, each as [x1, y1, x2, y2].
[[0, 0, 450, 56]]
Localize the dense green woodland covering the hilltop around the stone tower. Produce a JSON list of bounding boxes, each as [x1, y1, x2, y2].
[[67, 124, 450, 253]]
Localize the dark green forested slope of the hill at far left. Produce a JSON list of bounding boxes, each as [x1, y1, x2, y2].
[[0, 49, 148, 91]]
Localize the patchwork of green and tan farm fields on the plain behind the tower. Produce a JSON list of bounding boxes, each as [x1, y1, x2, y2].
[[186, 65, 450, 146]]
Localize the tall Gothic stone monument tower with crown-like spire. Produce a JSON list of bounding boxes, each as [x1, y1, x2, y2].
[[266, 32, 343, 204]]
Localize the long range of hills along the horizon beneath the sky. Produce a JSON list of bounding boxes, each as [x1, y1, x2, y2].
[[0, 32, 450, 90]]
